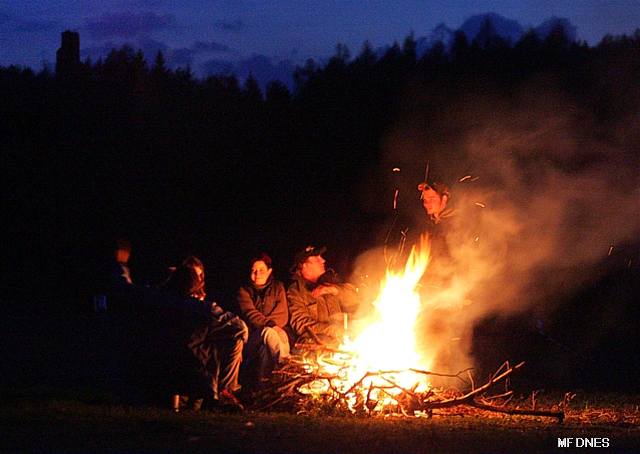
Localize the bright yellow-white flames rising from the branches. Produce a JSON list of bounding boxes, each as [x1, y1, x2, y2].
[[303, 239, 430, 409]]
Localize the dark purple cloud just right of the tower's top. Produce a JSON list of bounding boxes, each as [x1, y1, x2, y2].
[[85, 12, 176, 39]]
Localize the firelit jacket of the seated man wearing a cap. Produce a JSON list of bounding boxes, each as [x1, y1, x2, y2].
[[287, 274, 358, 342]]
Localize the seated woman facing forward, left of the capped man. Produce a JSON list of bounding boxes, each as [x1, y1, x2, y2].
[[237, 252, 289, 383]]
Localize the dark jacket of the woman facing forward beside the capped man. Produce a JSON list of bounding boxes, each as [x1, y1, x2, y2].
[[237, 278, 289, 330]]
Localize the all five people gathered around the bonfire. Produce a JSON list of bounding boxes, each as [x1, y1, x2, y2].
[[102, 179, 451, 408]]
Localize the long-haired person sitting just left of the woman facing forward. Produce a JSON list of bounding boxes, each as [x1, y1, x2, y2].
[[163, 261, 248, 409]]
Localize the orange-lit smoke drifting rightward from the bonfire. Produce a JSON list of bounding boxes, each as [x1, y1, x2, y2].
[[355, 74, 640, 378]]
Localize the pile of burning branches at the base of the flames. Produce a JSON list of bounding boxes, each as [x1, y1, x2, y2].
[[245, 344, 572, 423]]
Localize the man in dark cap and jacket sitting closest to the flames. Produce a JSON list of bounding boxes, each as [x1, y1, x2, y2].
[[287, 246, 358, 344]]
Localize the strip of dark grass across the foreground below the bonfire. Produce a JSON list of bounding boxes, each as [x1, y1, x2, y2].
[[0, 389, 640, 454]]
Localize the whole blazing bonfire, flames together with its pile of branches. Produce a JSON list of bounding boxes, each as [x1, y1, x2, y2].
[[254, 239, 571, 421]]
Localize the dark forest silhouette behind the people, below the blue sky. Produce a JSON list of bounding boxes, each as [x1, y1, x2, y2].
[[0, 24, 640, 312]]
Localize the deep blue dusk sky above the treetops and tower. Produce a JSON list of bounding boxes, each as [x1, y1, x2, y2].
[[0, 0, 640, 75]]
